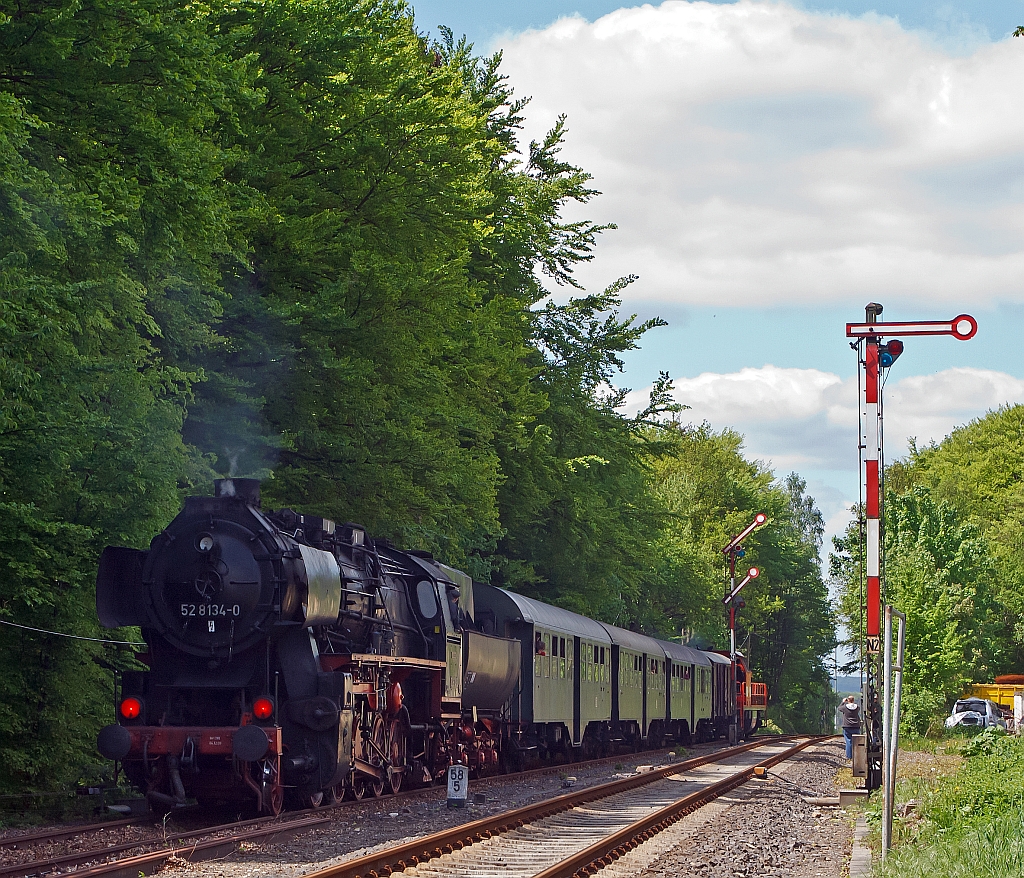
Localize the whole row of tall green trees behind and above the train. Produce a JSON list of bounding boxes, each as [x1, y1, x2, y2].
[[0, 0, 831, 794]]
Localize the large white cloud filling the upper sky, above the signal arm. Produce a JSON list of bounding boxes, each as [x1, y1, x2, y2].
[[504, 0, 1024, 305]]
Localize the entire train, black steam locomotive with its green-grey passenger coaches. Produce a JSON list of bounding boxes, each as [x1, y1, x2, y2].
[[96, 478, 767, 814]]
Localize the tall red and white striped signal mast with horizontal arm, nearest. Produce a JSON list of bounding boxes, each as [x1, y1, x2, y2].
[[846, 302, 978, 790]]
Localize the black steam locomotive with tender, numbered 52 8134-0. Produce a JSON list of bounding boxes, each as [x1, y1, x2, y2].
[[96, 479, 520, 813]]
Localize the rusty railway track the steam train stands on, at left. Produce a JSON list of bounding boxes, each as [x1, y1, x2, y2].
[[0, 749, 720, 878]]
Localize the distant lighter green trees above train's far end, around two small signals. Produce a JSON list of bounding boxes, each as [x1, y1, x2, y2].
[[645, 423, 835, 730]]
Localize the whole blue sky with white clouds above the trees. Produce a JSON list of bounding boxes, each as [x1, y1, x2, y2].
[[405, 0, 1024, 561]]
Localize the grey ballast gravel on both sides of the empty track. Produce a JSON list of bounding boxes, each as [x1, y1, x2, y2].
[[186, 741, 853, 878]]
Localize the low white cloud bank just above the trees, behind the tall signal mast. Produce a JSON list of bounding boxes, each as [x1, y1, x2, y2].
[[626, 365, 1024, 469]]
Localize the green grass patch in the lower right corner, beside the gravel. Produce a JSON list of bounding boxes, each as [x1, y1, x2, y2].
[[867, 736, 1024, 878]]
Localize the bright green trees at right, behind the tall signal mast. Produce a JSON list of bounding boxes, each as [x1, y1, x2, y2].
[[833, 406, 1024, 734]]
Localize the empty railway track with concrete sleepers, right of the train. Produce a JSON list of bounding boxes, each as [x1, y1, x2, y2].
[[306, 738, 822, 878]]
